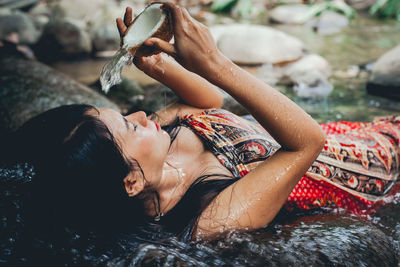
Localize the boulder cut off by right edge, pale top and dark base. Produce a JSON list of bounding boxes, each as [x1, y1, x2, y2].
[[367, 45, 400, 100]]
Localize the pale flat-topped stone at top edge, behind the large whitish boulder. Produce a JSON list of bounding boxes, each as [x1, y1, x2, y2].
[[268, 5, 311, 24]]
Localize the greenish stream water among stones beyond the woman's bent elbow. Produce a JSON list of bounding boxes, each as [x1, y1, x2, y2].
[[276, 15, 400, 122]]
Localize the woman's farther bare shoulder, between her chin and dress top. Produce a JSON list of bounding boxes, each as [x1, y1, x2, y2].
[[153, 103, 205, 126]]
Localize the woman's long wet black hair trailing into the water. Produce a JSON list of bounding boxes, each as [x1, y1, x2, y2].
[[10, 105, 238, 239]]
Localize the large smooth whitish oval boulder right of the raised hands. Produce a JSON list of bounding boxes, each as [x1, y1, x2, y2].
[[210, 24, 304, 65]]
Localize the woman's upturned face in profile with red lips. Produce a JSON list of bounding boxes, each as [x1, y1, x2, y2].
[[98, 108, 170, 192]]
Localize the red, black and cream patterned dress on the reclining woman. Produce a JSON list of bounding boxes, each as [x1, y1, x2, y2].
[[181, 109, 400, 214]]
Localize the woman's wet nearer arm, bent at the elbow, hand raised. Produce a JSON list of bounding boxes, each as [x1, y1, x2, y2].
[[149, 3, 325, 240]]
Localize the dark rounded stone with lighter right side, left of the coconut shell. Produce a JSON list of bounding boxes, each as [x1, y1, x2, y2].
[[36, 19, 92, 59]]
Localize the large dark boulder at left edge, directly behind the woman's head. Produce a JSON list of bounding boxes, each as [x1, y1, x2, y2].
[[0, 58, 119, 132]]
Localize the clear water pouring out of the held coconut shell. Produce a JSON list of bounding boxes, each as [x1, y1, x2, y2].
[[100, 48, 133, 94]]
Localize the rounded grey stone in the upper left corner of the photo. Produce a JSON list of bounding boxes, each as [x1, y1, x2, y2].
[[0, 12, 40, 44]]
